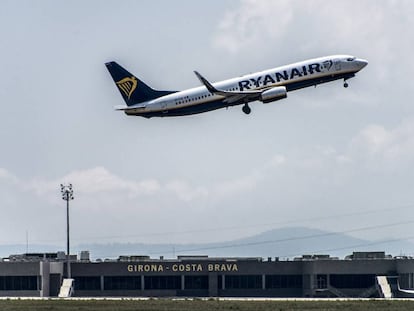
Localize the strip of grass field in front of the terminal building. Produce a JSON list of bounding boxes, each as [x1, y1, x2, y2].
[[0, 299, 414, 311]]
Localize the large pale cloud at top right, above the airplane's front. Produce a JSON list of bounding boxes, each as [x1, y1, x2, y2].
[[212, 0, 414, 72]]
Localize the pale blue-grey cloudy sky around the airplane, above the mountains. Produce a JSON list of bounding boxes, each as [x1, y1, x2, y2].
[[0, 0, 414, 255]]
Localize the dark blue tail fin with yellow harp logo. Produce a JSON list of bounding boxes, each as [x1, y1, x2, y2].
[[105, 62, 175, 106]]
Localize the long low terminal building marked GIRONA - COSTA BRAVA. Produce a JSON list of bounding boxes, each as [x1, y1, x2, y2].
[[0, 252, 414, 298]]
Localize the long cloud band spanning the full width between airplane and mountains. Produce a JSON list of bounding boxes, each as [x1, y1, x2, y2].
[[5, 119, 414, 217]]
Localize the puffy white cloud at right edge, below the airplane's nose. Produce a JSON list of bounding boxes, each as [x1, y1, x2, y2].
[[280, 118, 414, 174]]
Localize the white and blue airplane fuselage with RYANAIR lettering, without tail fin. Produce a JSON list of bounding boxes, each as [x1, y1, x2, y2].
[[120, 55, 367, 117]]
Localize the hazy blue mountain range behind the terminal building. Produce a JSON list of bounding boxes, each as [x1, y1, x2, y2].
[[0, 227, 414, 260]]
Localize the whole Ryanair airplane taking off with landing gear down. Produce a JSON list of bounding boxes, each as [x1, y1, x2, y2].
[[105, 55, 368, 118]]
